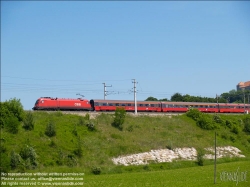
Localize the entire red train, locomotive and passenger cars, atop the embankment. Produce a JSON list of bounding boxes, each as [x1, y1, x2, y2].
[[33, 97, 250, 113]]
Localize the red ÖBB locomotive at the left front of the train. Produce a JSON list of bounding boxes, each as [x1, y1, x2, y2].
[[33, 97, 92, 110]]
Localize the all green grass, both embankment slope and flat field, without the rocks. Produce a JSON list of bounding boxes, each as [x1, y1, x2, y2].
[[1, 112, 250, 186]]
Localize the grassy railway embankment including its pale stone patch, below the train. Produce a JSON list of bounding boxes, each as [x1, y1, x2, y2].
[[1, 111, 250, 174]]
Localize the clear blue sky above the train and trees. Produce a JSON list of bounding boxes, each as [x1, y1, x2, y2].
[[1, 1, 250, 109]]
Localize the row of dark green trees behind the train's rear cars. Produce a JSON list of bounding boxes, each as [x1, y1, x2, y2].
[[145, 90, 250, 103]]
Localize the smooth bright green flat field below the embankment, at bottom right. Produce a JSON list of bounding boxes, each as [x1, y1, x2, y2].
[[84, 161, 250, 187]]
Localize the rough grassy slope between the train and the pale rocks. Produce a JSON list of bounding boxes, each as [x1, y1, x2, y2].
[[1, 112, 250, 173]]
